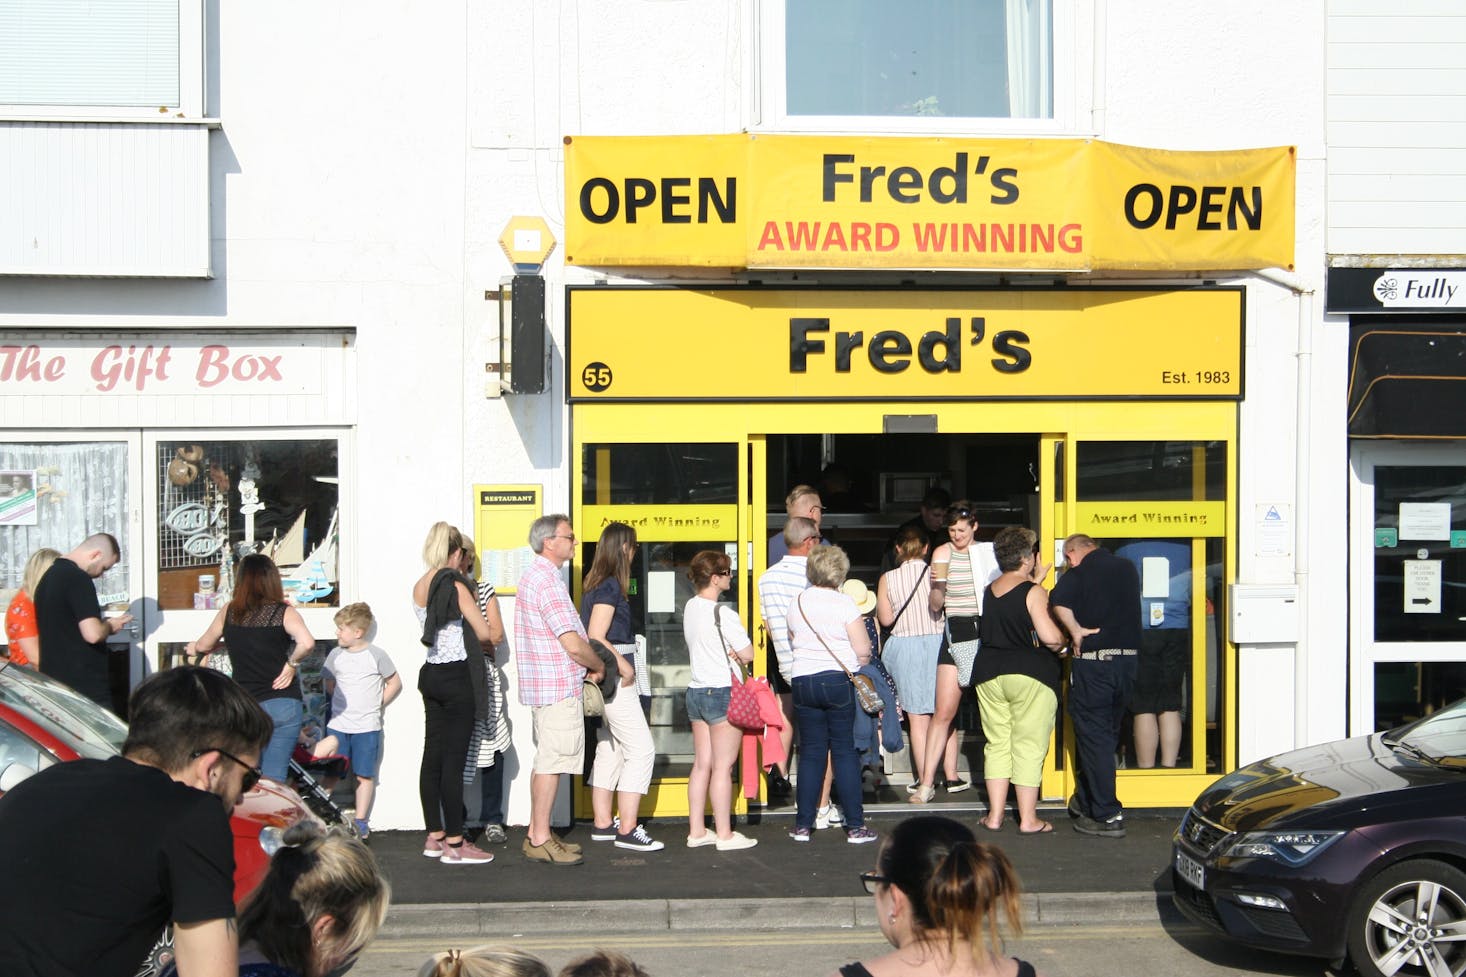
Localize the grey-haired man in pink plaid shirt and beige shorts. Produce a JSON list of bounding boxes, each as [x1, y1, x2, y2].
[[515, 513, 603, 866]]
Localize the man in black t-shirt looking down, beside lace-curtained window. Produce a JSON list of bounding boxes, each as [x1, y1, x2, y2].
[[35, 533, 132, 709]]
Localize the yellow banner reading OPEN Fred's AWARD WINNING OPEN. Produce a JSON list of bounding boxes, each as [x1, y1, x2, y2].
[[566, 135, 1294, 271]]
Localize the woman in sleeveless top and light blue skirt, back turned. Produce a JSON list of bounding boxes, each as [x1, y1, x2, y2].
[[875, 527, 957, 794]]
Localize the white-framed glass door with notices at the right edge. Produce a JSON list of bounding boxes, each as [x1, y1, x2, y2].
[[1349, 442, 1466, 735]]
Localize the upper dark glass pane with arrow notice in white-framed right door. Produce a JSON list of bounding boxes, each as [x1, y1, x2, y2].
[[1374, 465, 1466, 641]]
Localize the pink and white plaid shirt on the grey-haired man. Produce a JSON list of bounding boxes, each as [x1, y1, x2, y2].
[[515, 556, 585, 706]]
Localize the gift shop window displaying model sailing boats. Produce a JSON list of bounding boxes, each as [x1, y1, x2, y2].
[[154, 439, 340, 610]]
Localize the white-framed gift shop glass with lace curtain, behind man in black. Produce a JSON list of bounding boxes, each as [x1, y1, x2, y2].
[[0, 431, 150, 714]]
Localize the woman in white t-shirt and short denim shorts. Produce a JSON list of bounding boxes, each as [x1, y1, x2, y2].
[[682, 550, 758, 851]]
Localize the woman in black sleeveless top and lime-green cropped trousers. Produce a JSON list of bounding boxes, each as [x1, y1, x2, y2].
[[972, 527, 1064, 835]]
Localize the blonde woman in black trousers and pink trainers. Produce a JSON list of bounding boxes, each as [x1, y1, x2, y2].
[[412, 522, 504, 866]]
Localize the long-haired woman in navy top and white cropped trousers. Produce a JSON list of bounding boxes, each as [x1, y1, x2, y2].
[[581, 522, 664, 851]]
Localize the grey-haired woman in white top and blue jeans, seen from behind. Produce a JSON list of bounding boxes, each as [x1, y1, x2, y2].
[[789, 546, 877, 845]]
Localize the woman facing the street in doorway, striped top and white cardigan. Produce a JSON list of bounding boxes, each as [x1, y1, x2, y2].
[[912, 499, 1000, 804]]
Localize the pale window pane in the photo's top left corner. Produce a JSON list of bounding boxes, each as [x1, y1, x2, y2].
[[0, 0, 180, 107]]
